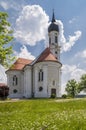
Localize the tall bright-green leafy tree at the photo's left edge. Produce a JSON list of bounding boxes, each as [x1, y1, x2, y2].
[[0, 12, 14, 67]]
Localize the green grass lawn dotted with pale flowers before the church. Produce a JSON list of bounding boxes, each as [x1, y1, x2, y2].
[[0, 98, 86, 130]]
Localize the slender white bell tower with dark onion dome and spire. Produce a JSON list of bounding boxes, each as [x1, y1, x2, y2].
[[48, 11, 60, 61]]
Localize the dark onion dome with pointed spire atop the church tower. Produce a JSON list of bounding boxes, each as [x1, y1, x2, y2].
[[48, 12, 59, 33]]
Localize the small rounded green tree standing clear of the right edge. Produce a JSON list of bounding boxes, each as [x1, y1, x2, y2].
[[65, 79, 78, 98]]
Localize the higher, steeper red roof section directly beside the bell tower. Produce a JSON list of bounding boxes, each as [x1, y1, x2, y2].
[[35, 48, 58, 63]]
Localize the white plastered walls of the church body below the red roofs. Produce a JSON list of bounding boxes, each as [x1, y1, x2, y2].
[[7, 61, 61, 98]]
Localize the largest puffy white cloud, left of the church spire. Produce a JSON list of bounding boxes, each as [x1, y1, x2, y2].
[[14, 5, 49, 46]]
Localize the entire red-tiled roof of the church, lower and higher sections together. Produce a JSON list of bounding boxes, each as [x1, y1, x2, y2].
[[7, 47, 61, 71]]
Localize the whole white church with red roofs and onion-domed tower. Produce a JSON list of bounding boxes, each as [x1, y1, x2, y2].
[[6, 12, 62, 98]]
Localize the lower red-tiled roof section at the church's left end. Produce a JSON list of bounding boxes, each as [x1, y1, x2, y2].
[[9, 58, 32, 70]]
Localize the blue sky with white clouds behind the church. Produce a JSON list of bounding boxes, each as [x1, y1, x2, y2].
[[0, 0, 86, 92]]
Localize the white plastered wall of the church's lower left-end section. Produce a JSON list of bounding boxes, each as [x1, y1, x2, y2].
[[7, 70, 24, 98]]
